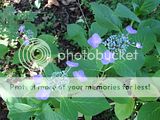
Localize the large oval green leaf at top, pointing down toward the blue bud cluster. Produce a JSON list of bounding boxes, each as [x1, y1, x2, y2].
[[91, 3, 122, 31]]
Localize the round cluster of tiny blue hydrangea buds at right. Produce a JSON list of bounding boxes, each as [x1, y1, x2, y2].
[[103, 34, 130, 53]]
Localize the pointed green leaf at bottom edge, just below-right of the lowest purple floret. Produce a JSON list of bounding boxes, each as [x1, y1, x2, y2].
[[38, 103, 65, 120]]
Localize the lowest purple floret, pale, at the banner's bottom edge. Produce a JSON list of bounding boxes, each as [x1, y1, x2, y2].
[[36, 89, 50, 100]]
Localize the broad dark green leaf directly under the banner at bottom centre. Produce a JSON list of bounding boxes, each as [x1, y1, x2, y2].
[[72, 98, 110, 116]]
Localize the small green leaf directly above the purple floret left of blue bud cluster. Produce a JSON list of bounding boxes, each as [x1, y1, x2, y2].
[[89, 22, 108, 37]]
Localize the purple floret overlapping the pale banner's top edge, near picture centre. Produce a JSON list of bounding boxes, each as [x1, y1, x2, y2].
[[73, 70, 87, 82]]
